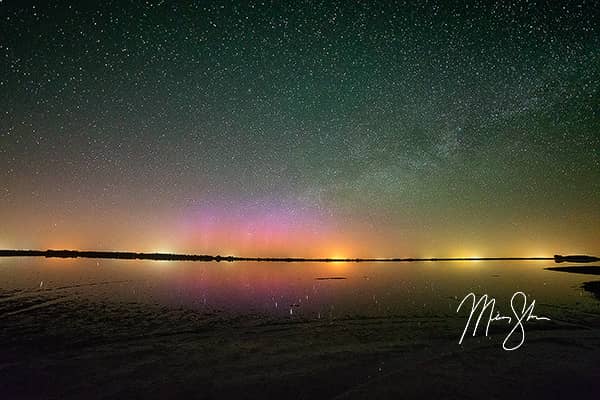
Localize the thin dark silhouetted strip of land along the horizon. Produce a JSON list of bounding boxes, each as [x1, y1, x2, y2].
[[0, 250, 600, 263]]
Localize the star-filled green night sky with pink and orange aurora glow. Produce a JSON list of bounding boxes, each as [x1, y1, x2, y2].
[[0, 0, 600, 257]]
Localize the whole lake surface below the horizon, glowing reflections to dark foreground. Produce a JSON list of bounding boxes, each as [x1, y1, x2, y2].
[[0, 258, 600, 398]]
